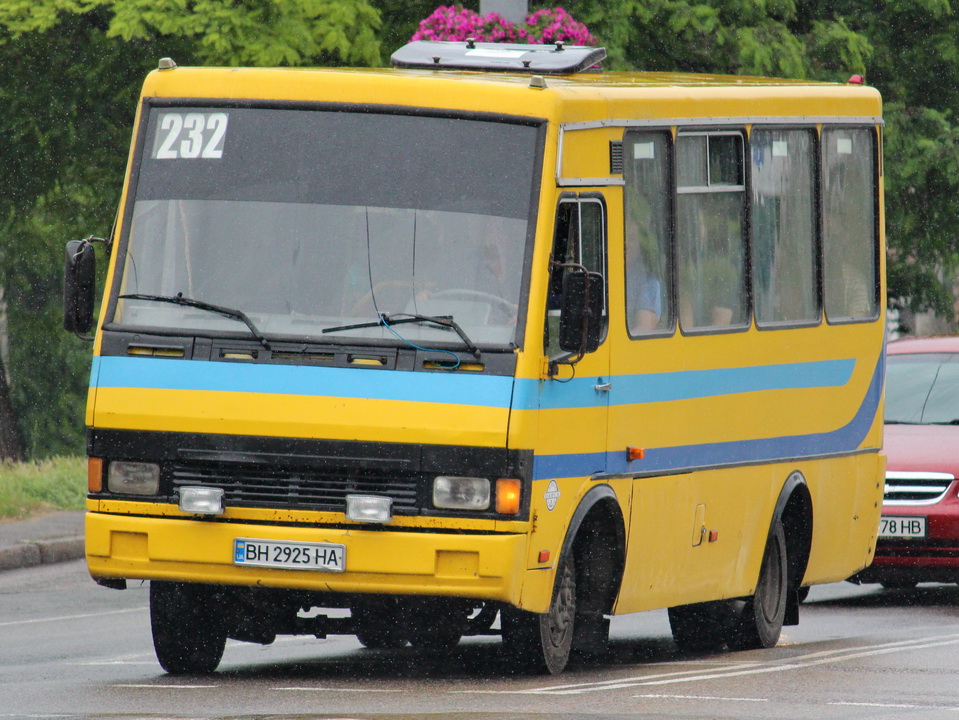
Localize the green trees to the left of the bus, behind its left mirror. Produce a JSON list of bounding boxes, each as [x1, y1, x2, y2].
[[0, 0, 380, 457]]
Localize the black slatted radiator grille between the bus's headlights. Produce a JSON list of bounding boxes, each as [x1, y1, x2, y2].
[[169, 461, 421, 514]]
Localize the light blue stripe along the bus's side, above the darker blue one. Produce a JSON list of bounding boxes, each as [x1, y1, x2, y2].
[[513, 358, 856, 410]]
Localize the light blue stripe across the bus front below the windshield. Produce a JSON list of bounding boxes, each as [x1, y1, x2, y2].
[[91, 357, 513, 409]]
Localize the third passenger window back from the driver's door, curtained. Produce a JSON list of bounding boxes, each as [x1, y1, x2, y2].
[[749, 129, 819, 325]]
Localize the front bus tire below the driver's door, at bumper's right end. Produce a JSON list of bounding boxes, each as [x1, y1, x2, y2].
[[502, 556, 576, 675]]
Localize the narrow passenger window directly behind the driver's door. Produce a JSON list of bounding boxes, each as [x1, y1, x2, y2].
[[623, 132, 673, 337]]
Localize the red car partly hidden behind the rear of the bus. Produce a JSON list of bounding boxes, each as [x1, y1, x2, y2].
[[851, 337, 959, 588]]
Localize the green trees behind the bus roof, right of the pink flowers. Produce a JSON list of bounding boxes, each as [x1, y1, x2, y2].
[[548, 0, 959, 317]]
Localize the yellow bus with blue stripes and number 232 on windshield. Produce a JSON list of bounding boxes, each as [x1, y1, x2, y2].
[[65, 41, 885, 673]]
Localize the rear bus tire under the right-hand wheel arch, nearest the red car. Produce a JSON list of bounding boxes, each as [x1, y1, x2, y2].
[[726, 518, 788, 650]]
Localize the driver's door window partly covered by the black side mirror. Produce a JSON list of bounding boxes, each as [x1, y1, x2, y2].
[[544, 197, 607, 358]]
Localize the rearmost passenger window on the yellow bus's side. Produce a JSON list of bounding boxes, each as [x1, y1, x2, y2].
[[822, 128, 879, 320]]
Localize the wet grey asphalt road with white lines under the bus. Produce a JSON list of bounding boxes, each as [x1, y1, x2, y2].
[[0, 561, 959, 720]]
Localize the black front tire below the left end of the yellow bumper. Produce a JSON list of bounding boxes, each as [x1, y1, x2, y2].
[[150, 580, 227, 675]]
